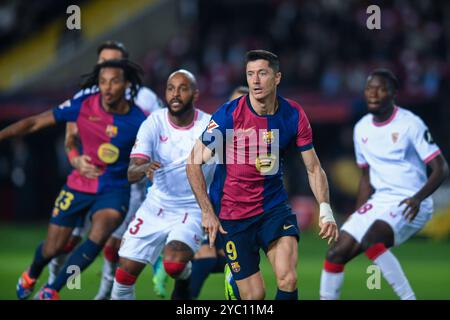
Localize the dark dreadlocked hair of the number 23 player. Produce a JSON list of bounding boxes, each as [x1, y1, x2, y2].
[[81, 59, 143, 101]]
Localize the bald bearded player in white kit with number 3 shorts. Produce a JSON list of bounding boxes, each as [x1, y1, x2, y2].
[[111, 70, 214, 299]]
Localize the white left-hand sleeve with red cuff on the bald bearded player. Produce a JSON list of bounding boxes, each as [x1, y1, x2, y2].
[[130, 115, 158, 160]]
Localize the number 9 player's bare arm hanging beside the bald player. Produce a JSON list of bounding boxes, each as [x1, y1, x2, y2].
[[186, 140, 226, 248]]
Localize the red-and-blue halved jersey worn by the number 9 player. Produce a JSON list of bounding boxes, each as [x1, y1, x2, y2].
[[200, 95, 313, 220]]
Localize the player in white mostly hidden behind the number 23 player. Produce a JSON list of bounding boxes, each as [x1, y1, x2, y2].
[[48, 41, 165, 300]]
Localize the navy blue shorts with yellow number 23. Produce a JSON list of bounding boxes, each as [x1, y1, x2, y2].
[[50, 185, 130, 228]]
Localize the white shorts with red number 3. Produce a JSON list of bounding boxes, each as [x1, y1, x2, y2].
[[119, 198, 203, 264]]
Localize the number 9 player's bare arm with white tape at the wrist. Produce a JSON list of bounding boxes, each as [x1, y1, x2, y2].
[[302, 148, 339, 244]]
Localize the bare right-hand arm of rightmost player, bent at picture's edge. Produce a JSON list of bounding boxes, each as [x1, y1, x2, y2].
[[399, 154, 449, 222]]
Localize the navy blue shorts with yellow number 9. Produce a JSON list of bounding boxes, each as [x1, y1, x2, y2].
[[218, 203, 300, 280]]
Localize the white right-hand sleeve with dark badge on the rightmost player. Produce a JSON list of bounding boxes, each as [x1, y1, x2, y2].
[[410, 117, 441, 163]]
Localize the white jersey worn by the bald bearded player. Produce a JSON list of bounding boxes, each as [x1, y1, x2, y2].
[[130, 108, 215, 207]]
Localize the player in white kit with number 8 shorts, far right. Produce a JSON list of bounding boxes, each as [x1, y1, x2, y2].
[[320, 69, 448, 300]]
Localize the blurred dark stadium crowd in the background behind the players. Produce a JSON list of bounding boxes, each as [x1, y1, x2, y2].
[[0, 0, 450, 238]]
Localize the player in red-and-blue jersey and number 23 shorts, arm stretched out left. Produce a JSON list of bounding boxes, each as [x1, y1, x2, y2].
[[0, 60, 145, 299]]
